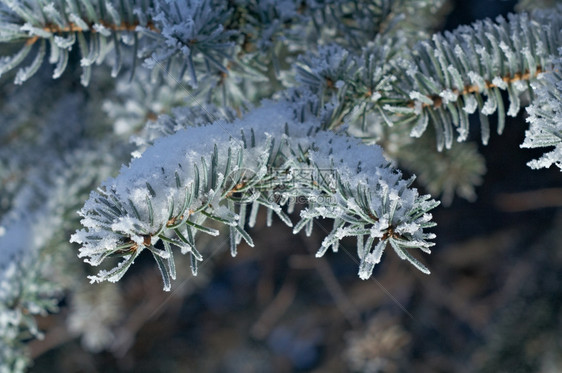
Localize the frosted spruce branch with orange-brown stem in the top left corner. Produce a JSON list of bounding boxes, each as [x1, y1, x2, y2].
[[0, 0, 237, 85]]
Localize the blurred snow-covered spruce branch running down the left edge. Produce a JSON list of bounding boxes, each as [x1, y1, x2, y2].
[[0, 146, 103, 372]]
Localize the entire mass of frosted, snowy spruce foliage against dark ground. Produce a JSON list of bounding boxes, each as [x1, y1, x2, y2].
[[0, 0, 562, 372]]
